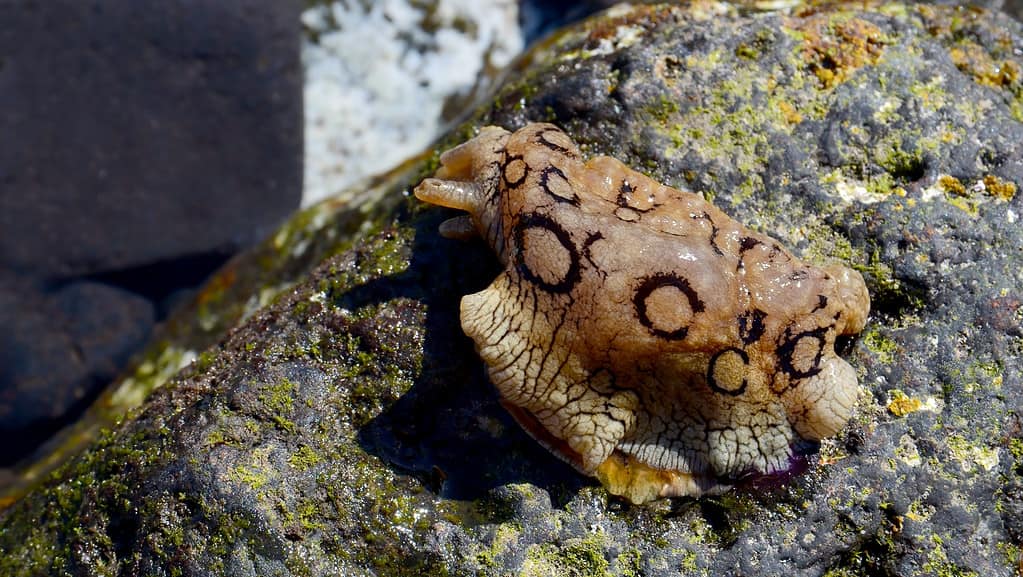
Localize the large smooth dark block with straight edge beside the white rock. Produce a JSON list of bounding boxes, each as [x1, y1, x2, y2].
[[0, 0, 302, 277]]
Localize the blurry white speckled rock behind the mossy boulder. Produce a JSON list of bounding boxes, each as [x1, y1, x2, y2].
[[302, 0, 523, 206]]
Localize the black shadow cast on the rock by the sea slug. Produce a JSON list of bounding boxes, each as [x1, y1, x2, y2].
[[347, 211, 586, 503]]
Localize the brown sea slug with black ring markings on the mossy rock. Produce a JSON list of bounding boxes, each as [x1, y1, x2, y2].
[[415, 124, 870, 502]]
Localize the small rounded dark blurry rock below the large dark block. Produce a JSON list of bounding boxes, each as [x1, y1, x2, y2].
[[0, 276, 153, 464]]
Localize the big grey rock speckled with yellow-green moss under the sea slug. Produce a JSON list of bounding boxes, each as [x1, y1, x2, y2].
[[0, 3, 1023, 577]]
